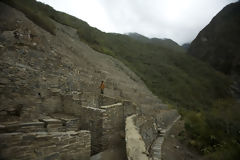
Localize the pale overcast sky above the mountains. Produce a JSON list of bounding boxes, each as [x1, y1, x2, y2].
[[39, 0, 237, 44]]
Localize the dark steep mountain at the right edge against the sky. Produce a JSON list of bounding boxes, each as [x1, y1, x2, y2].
[[188, 2, 240, 75]]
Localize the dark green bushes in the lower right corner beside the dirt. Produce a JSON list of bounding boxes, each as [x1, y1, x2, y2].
[[182, 98, 240, 160]]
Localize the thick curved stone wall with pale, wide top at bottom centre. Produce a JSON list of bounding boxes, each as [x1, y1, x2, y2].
[[125, 115, 158, 160]]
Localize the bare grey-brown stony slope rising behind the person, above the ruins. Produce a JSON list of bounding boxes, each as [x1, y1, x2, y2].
[[0, 3, 166, 121]]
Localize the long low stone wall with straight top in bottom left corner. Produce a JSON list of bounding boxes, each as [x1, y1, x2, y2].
[[0, 130, 91, 160]]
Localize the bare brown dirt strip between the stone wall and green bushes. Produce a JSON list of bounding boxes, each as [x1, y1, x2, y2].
[[162, 120, 202, 160]]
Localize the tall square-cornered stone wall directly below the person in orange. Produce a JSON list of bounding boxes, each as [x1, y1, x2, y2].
[[78, 100, 136, 154]]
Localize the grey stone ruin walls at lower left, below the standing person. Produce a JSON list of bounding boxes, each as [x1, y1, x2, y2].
[[0, 94, 136, 160]]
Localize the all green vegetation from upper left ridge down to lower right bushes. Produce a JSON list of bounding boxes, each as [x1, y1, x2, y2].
[[4, 0, 240, 160]]
